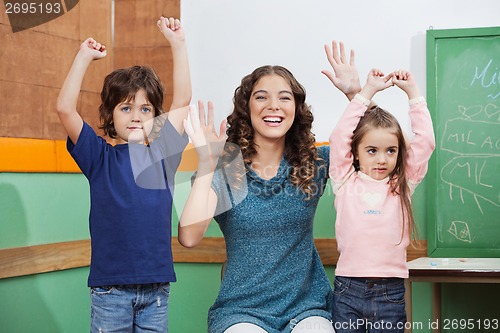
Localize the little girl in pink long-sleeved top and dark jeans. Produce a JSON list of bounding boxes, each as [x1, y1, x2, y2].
[[330, 69, 435, 333]]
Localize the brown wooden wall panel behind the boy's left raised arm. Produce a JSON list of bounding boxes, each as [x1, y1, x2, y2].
[[0, 0, 113, 140]]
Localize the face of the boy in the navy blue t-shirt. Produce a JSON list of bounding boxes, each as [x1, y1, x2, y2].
[[113, 89, 155, 144]]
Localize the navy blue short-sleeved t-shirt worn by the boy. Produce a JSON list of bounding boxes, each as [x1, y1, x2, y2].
[[67, 121, 188, 287]]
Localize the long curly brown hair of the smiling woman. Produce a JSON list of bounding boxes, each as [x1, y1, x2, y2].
[[227, 65, 318, 199]]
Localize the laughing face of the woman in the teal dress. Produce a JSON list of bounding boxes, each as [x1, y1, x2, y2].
[[249, 74, 295, 144]]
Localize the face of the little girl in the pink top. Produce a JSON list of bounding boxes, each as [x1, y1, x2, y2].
[[356, 128, 399, 180]]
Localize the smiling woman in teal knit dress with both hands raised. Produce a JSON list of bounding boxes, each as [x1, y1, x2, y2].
[[179, 43, 360, 333]]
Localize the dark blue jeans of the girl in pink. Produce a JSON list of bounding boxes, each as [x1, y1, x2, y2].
[[332, 276, 406, 333]]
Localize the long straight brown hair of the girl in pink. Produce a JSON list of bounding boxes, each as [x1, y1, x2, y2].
[[351, 106, 418, 246]]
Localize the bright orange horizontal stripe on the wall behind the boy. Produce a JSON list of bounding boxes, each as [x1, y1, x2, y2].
[[0, 137, 328, 173]]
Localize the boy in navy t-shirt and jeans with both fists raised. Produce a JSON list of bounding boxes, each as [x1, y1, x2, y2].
[[57, 17, 191, 333]]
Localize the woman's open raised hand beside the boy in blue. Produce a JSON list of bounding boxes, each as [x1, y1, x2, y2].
[[184, 101, 227, 171]]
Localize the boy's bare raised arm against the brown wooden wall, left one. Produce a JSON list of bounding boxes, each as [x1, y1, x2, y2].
[[57, 38, 106, 144]]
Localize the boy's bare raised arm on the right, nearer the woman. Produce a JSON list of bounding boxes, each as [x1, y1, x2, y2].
[[157, 16, 192, 134]]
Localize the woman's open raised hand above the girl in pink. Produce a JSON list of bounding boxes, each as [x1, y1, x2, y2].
[[321, 41, 361, 100]]
